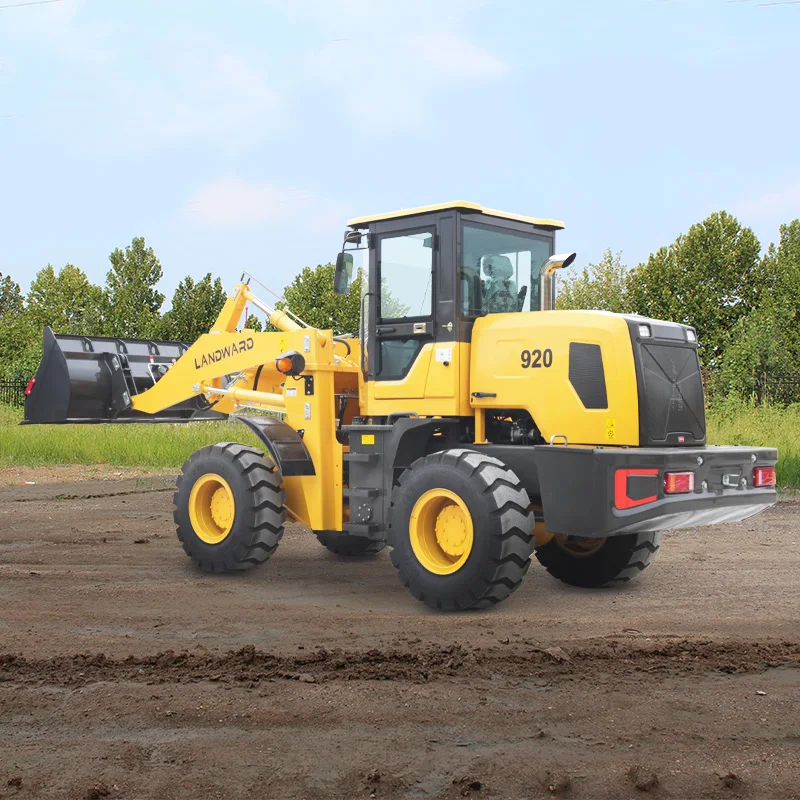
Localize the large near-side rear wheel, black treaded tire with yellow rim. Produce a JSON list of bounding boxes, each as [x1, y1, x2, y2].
[[388, 449, 534, 611]]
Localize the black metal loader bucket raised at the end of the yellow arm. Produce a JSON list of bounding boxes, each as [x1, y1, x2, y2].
[[23, 328, 225, 425]]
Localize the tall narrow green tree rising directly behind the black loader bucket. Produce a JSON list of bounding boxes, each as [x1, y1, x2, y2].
[[104, 237, 164, 338]]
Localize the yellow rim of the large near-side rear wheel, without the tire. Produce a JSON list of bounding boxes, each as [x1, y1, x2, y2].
[[408, 489, 474, 575]]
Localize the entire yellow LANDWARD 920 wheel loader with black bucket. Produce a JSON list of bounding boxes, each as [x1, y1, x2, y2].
[[25, 202, 777, 610]]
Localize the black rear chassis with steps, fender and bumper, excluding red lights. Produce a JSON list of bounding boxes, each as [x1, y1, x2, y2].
[[344, 416, 777, 538]]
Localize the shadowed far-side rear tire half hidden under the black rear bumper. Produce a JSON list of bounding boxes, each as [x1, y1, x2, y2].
[[536, 533, 662, 589]]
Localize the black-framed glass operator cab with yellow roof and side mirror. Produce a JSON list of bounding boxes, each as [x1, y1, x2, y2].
[[335, 202, 564, 396]]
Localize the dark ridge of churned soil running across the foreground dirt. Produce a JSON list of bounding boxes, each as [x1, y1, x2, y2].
[[0, 639, 800, 685]]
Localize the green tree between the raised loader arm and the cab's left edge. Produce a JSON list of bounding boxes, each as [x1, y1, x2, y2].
[[275, 264, 361, 334]]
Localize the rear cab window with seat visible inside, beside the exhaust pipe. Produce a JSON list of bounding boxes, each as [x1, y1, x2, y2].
[[459, 224, 553, 317]]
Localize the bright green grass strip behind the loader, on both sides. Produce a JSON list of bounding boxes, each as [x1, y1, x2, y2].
[[0, 402, 800, 489]]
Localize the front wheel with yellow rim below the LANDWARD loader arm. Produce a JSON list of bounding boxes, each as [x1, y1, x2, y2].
[[173, 442, 286, 572]]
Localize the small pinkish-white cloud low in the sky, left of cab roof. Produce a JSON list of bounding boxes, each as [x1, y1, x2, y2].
[[185, 178, 346, 231]]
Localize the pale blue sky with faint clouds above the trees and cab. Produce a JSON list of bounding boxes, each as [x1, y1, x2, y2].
[[0, 0, 800, 306]]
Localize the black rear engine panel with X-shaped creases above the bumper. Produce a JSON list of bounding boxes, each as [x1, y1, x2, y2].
[[639, 342, 706, 445]]
